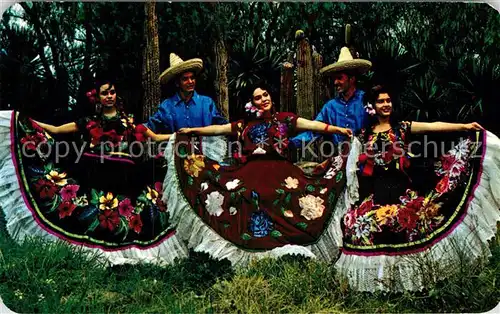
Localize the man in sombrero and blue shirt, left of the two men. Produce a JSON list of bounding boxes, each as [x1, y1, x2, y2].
[[145, 53, 227, 134]]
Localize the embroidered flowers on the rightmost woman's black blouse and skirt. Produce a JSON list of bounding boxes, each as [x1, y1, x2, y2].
[[342, 125, 474, 248]]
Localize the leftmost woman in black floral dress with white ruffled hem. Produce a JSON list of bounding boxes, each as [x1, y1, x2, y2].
[[0, 81, 186, 264]]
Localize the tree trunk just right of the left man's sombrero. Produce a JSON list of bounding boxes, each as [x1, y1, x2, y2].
[[213, 36, 229, 120]]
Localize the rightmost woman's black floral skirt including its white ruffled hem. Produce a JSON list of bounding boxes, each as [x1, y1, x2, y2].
[[336, 131, 500, 291]]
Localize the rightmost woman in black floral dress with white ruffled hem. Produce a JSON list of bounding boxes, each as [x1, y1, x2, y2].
[[336, 86, 500, 291]]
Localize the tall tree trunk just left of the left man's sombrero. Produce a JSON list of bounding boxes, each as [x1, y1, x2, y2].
[[142, 1, 161, 121]]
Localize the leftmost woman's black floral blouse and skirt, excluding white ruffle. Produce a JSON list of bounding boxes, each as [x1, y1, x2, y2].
[[7, 113, 174, 250]]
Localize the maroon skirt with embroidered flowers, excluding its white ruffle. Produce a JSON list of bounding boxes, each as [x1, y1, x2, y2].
[[175, 135, 345, 251]]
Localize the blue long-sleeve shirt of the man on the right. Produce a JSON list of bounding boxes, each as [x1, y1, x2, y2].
[[292, 90, 368, 147]]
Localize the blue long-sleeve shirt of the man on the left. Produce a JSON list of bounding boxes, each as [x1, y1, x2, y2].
[[144, 92, 227, 134]]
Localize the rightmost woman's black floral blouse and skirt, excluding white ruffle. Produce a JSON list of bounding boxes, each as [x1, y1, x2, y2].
[[342, 124, 484, 256]]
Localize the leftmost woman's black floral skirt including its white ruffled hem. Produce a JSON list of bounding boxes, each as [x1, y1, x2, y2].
[[0, 112, 184, 262]]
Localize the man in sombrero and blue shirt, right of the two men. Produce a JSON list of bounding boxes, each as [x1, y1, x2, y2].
[[292, 47, 372, 147]]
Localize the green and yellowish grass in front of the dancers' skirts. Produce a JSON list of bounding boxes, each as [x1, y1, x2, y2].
[[0, 201, 500, 313]]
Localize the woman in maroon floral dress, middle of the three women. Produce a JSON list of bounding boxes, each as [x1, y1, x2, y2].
[[160, 85, 352, 264]]
